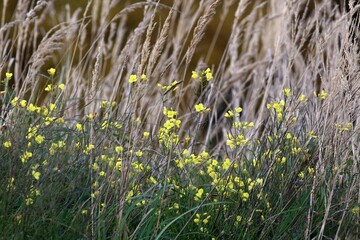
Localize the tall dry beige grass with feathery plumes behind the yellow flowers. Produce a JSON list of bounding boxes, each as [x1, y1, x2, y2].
[[0, 0, 360, 239]]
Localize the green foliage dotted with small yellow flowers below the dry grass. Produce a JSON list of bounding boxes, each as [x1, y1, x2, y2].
[[0, 82, 358, 239]]
